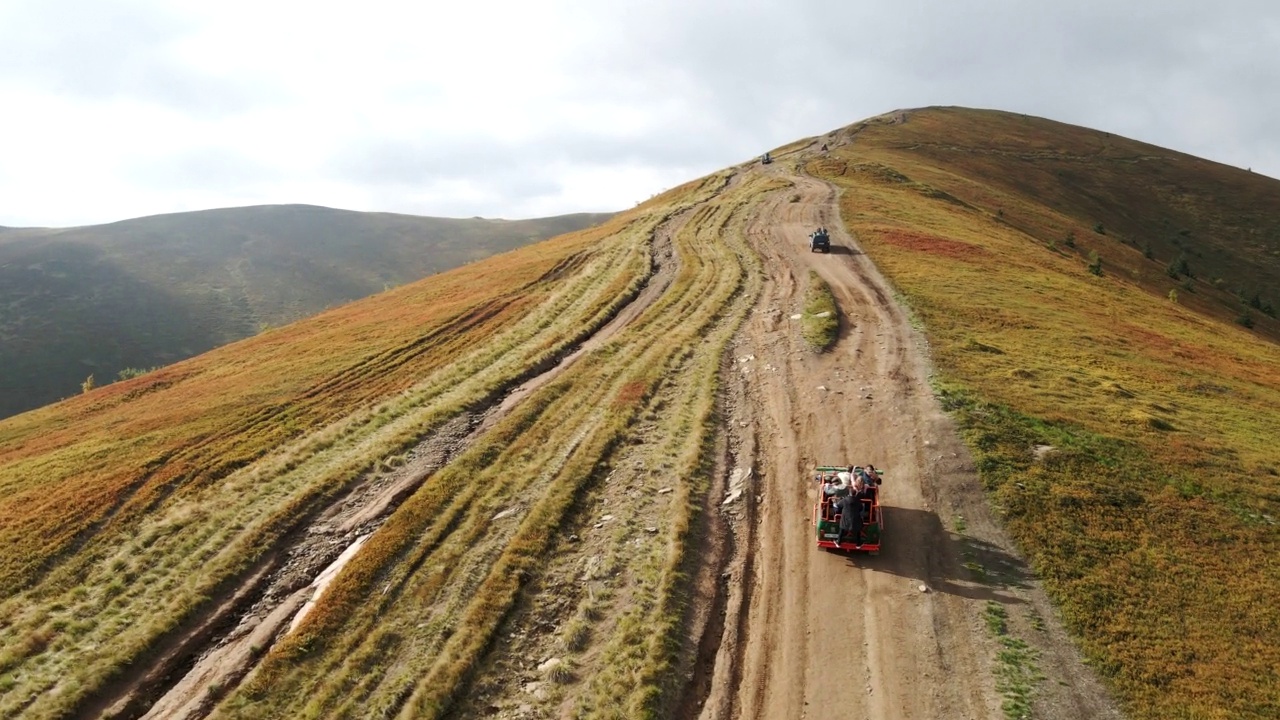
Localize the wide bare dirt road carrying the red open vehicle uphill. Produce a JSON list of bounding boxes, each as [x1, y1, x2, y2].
[[701, 154, 1114, 719]]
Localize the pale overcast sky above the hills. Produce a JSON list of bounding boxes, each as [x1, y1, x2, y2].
[[0, 0, 1280, 227]]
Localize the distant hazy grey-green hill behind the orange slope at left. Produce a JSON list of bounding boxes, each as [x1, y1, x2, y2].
[[0, 205, 608, 416]]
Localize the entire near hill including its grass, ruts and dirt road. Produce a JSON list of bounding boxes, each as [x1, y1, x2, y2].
[[0, 109, 1280, 719]]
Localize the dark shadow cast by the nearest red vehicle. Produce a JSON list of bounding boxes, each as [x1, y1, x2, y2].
[[841, 506, 1033, 605]]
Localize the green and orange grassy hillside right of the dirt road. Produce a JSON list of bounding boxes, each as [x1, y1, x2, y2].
[[809, 109, 1280, 719]]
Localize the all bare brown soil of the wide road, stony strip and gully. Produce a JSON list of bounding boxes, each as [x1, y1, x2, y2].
[[115, 142, 1119, 720]]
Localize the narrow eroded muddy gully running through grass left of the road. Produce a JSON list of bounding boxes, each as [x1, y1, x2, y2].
[[120, 202, 687, 720]]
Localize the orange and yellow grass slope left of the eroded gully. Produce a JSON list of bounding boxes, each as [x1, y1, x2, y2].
[[0, 176, 714, 717]]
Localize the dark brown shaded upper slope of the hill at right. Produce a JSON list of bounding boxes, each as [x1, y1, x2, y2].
[[834, 108, 1280, 340]]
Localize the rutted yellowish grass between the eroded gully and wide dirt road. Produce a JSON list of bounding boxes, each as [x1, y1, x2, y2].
[[202, 172, 755, 717]]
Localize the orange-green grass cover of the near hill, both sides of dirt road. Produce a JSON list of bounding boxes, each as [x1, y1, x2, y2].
[[0, 109, 1280, 719]]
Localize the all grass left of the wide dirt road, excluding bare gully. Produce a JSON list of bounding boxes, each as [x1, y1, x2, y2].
[[0, 169, 754, 717]]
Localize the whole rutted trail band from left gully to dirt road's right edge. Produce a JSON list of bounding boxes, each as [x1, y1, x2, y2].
[[120, 151, 1103, 720]]
